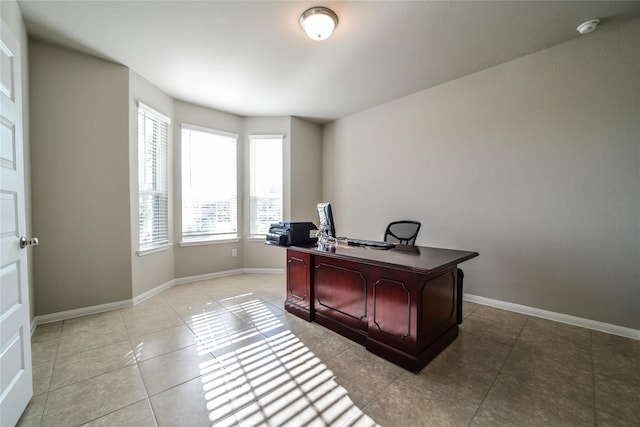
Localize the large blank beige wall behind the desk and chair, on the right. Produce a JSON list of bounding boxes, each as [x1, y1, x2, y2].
[[323, 19, 640, 329]]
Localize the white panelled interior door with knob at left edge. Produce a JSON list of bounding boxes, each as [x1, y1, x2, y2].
[[0, 16, 33, 426]]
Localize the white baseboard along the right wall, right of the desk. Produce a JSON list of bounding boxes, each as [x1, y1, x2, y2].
[[463, 293, 640, 340]]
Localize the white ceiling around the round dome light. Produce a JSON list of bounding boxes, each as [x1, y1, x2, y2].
[[19, 0, 640, 122]]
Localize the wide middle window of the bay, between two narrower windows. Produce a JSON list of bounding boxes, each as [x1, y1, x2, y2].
[[182, 124, 238, 242]]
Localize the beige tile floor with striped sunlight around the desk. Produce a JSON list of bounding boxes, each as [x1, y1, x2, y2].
[[19, 274, 640, 427]]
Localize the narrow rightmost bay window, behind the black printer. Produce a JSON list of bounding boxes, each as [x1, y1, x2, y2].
[[249, 135, 283, 235]]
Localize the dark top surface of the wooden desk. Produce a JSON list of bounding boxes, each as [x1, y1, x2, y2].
[[289, 244, 479, 274]]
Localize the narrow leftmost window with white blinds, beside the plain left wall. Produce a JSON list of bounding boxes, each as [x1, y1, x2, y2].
[[138, 103, 169, 251]]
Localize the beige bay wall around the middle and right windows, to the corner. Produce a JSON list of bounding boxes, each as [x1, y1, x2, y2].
[[174, 112, 322, 278]]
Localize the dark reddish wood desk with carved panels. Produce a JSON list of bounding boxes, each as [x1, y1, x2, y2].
[[285, 245, 478, 372]]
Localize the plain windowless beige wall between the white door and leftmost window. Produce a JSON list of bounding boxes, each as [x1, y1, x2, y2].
[[29, 40, 132, 315]]
